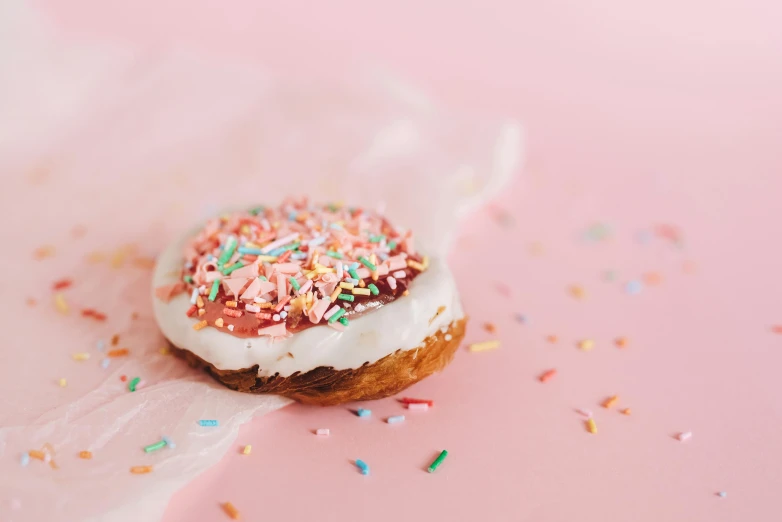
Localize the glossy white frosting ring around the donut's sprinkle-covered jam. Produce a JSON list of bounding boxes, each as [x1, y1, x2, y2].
[[152, 230, 464, 377]]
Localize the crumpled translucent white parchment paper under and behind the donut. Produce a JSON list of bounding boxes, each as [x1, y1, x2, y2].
[[0, 2, 521, 522]]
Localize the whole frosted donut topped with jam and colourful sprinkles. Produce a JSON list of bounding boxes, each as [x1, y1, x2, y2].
[[153, 199, 467, 405]]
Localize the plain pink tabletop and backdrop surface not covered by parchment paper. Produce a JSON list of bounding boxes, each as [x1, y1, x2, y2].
[[35, 0, 782, 522]]
